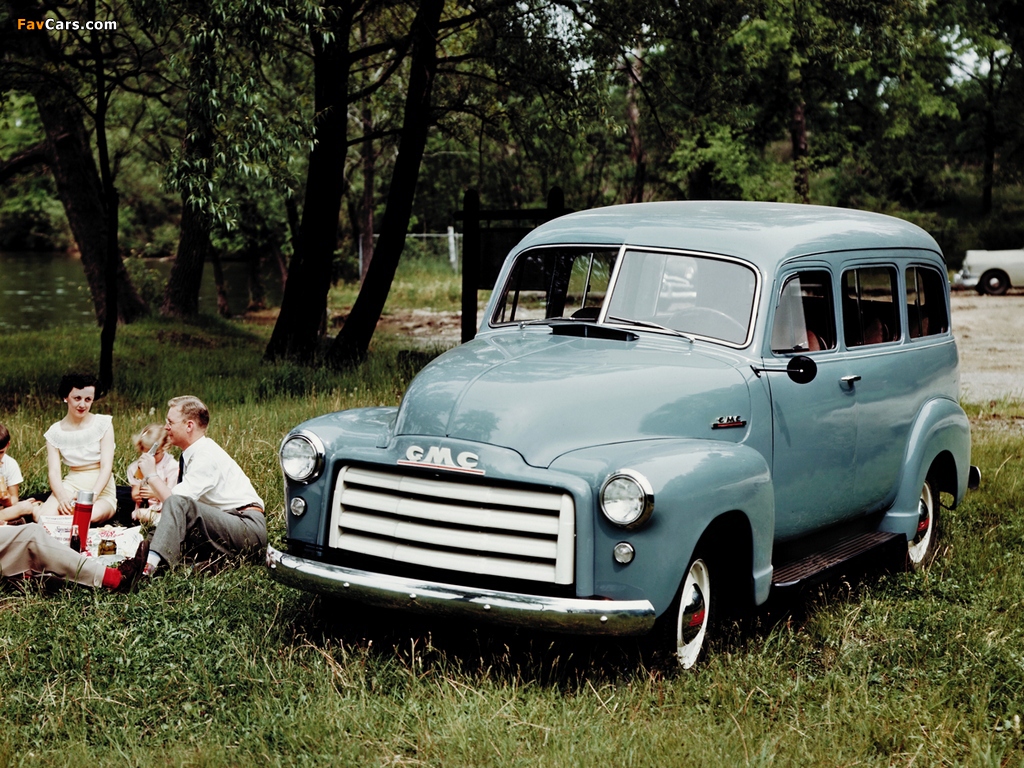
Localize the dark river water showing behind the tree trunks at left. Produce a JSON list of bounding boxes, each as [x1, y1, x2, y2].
[[0, 251, 281, 331]]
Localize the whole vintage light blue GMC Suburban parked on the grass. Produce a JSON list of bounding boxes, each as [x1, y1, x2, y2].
[[267, 202, 979, 667]]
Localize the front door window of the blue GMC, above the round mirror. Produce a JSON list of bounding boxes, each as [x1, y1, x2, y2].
[[771, 269, 836, 352]]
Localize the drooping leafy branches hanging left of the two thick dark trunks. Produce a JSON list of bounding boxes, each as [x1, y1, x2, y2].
[[166, 0, 321, 231]]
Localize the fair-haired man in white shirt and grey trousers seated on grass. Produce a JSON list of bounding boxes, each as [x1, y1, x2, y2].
[[139, 395, 266, 575]]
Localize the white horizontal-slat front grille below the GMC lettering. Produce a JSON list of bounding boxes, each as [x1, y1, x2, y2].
[[328, 466, 575, 584]]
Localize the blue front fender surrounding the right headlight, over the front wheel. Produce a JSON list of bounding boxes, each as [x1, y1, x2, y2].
[[551, 439, 775, 614]]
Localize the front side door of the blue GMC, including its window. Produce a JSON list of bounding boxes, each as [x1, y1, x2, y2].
[[765, 265, 857, 541]]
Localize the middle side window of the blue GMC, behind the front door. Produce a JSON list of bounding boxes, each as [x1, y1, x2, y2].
[[843, 266, 900, 347]]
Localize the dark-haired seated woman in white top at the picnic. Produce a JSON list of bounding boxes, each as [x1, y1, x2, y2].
[[35, 374, 117, 523]]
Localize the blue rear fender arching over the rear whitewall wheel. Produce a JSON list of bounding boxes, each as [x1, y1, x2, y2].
[[880, 397, 971, 539]]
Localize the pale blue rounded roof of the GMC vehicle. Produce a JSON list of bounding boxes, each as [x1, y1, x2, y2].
[[516, 201, 941, 270]]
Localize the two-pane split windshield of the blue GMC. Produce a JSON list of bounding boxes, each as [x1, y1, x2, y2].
[[490, 247, 757, 345]]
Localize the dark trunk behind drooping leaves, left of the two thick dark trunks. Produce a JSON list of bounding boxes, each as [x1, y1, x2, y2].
[[160, 9, 217, 317]]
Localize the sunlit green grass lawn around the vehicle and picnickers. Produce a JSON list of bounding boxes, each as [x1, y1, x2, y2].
[[0, 292, 1024, 766]]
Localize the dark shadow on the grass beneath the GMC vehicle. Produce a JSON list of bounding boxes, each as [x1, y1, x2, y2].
[[276, 544, 904, 692]]
